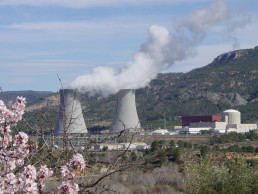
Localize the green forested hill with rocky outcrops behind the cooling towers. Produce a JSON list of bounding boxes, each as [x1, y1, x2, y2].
[[2, 47, 258, 125]]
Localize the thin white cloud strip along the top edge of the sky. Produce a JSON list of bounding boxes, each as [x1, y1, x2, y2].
[[0, 0, 211, 8]]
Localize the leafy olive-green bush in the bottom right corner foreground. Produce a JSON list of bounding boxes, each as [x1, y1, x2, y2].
[[185, 158, 258, 194]]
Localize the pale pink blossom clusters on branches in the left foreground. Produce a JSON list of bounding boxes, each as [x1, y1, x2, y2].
[[0, 97, 85, 194]]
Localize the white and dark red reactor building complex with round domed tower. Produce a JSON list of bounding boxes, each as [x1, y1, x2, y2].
[[179, 109, 257, 134]]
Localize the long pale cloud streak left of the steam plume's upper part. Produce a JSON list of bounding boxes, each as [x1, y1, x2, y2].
[[0, 16, 165, 42]]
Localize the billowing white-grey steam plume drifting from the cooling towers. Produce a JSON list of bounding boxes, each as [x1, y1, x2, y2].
[[68, 1, 248, 96]]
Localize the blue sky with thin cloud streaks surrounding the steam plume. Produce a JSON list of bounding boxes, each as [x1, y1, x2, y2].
[[0, 0, 258, 91]]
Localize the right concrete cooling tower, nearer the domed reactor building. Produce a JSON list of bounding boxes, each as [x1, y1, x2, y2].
[[110, 89, 141, 134]]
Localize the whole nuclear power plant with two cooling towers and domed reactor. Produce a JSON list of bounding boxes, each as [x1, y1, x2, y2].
[[47, 89, 257, 150]]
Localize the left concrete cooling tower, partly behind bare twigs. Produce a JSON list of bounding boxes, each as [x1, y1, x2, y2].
[[54, 89, 88, 136]]
